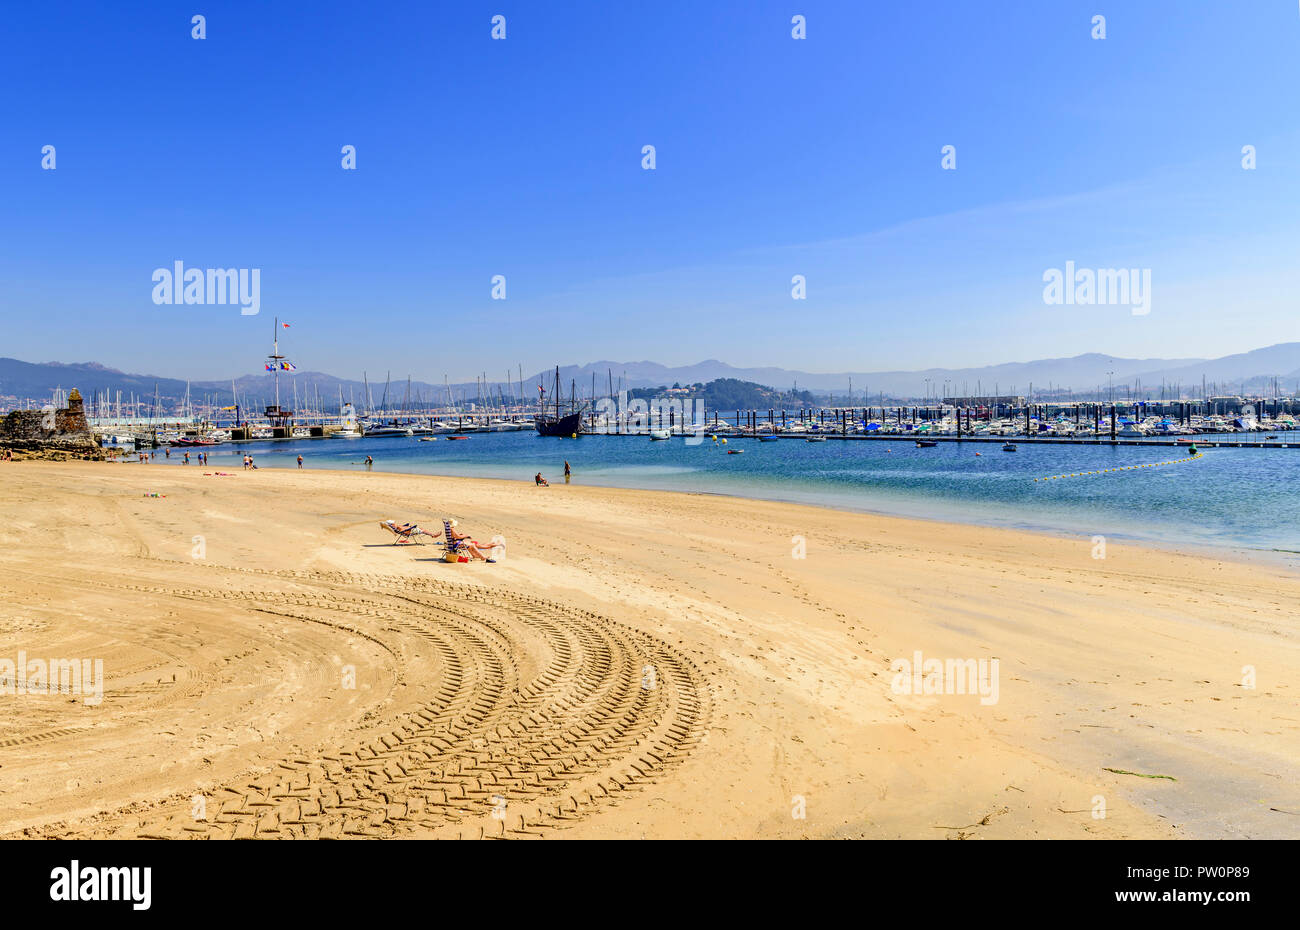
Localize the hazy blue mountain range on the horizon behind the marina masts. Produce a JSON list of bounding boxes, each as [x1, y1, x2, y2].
[[0, 342, 1300, 410]]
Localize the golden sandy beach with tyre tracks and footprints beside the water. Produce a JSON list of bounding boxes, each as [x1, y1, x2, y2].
[[0, 462, 1300, 839]]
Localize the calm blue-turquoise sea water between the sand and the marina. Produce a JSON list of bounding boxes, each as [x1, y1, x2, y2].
[[170, 432, 1300, 554]]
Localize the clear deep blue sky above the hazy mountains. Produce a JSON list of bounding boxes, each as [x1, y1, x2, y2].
[[0, 0, 1300, 381]]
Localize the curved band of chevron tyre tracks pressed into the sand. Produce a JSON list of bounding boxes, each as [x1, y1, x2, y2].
[[23, 566, 709, 839]]
